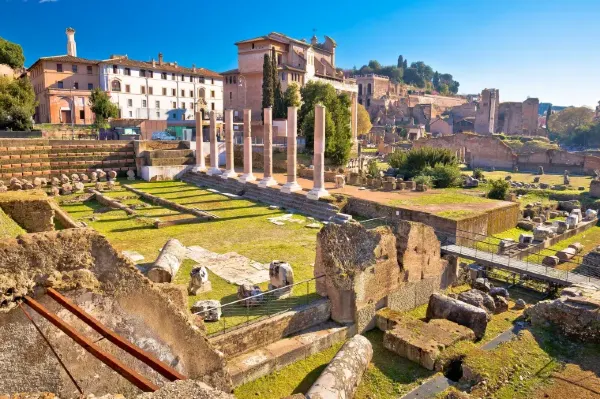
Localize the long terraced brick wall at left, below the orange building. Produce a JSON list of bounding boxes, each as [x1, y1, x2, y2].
[[0, 139, 135, 180]]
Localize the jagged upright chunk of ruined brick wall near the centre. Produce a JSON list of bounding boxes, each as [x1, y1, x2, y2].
[[315, 221, 456, 334]]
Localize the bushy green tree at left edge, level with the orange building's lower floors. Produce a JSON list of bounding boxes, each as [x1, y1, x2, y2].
[[0, 77, 37, 131]]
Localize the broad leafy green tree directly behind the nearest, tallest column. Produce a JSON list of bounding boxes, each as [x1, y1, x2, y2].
[[298, 82, 352, 165]]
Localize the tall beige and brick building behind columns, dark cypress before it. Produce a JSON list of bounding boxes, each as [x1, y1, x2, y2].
[[222, 32, 358, 121]]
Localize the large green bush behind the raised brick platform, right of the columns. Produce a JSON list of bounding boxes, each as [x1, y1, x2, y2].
[[388, 147, 458, 179]]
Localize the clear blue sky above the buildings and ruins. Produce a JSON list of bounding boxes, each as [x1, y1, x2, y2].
[[0, 0, 600, 106]]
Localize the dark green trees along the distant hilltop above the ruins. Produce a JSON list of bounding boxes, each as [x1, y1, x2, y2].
[[346, 55, 460, 95]]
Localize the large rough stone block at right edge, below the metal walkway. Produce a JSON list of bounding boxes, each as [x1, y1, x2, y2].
[[525, 284, 600, 343]]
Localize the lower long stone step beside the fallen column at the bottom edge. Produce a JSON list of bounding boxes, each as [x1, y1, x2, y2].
[[227, 321, 356, 387]]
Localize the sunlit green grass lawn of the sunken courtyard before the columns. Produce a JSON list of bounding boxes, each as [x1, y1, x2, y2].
[[60, 181, 318, 333]]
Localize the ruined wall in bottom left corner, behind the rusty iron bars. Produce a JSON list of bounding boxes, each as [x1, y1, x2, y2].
[[0, 229, 231, 398]]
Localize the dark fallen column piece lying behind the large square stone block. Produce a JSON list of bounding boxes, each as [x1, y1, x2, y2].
[[427, 293, 489, 339]]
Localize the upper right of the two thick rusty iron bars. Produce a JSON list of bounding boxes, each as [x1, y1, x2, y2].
[[47, 288, 187, 381]]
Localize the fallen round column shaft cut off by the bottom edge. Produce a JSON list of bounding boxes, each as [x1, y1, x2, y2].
[[306, 335, 373, 399]]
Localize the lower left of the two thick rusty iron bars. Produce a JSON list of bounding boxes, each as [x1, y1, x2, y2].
[[23, 296, 159, 392]]
